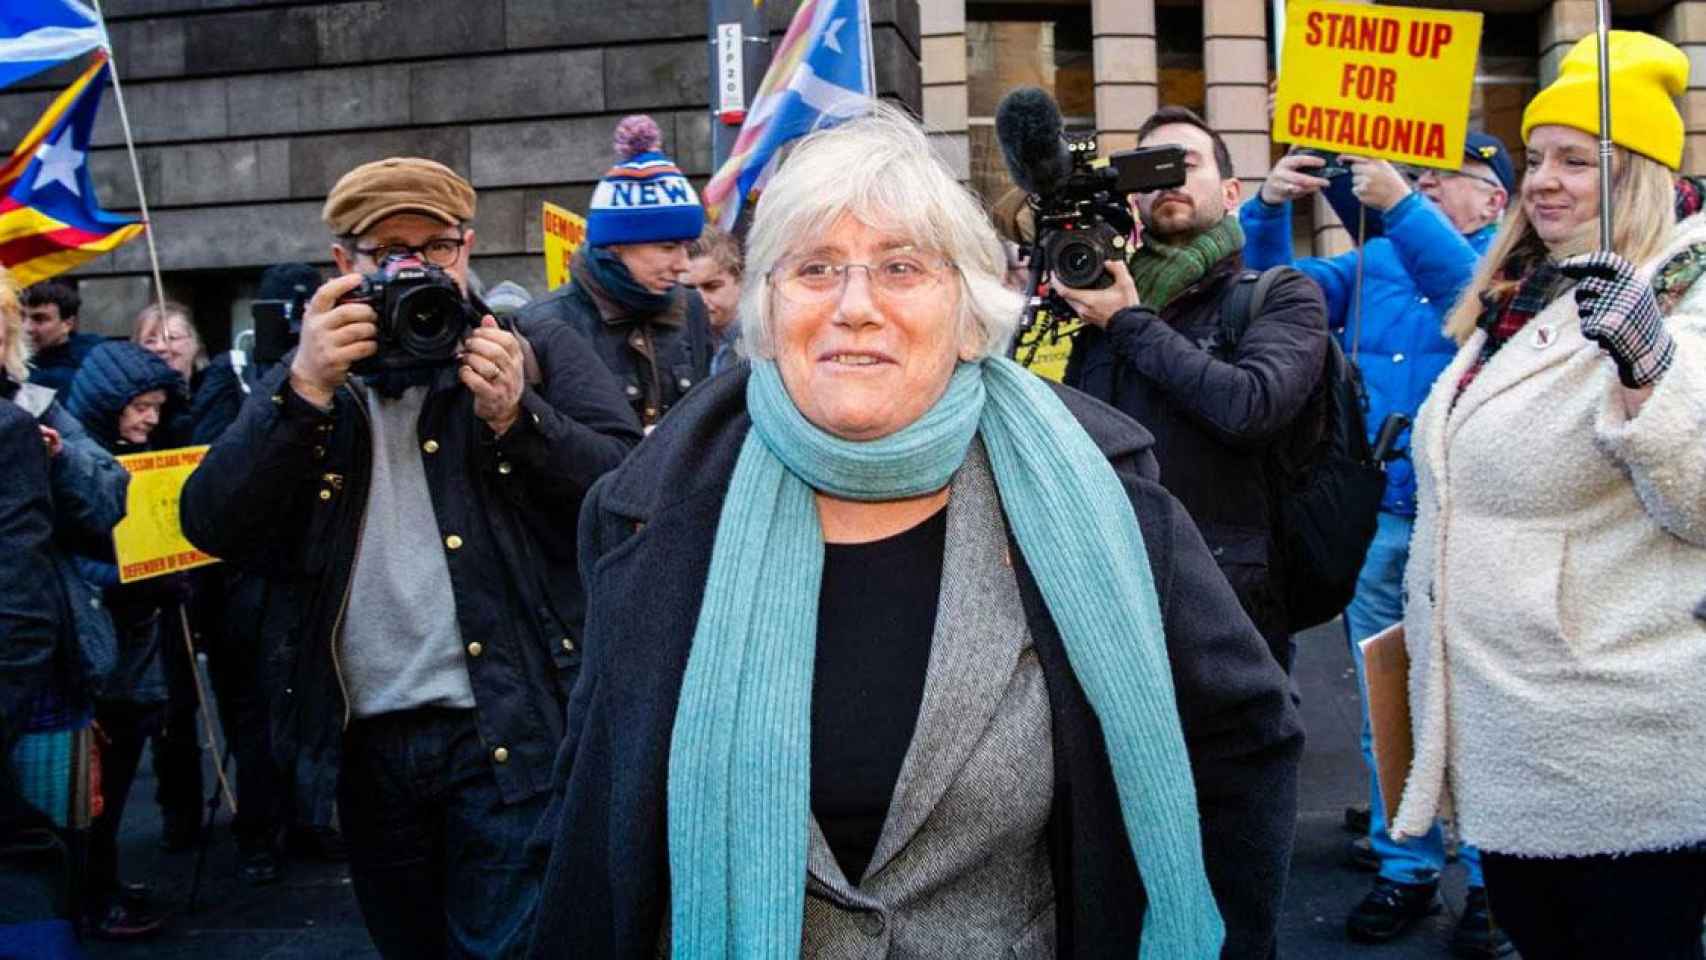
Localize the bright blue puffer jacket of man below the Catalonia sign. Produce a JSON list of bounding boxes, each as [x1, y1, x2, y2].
[[1239, 193, 1498, 517]]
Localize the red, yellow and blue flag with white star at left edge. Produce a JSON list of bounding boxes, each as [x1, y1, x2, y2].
[[0, 53, 143, 286]]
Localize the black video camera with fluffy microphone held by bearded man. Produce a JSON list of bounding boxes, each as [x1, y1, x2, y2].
[[995, 87, 1186, 348]]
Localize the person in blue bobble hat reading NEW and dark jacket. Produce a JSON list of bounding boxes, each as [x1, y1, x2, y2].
[[520, 114, 717, 431]]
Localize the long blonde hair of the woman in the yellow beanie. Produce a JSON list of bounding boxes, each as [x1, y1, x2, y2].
[[1445, 147, 1677, 346]]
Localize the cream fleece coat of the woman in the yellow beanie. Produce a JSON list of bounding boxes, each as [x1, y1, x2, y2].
[[1392, 217, 1706, 858]]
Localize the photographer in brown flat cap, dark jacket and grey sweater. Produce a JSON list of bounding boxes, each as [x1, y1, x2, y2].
[[181, 159, 640, 957]]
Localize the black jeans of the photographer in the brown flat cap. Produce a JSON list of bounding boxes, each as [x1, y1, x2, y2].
[[338, 709, 549, 958]]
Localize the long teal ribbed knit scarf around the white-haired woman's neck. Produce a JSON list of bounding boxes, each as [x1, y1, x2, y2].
[[669, 358, 1223, 960]]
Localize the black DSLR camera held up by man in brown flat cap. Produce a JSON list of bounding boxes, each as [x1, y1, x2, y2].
[[338, 257, 479, 373]]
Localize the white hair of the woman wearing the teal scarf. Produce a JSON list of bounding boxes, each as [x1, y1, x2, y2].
[[740, 101, 1025, 358]]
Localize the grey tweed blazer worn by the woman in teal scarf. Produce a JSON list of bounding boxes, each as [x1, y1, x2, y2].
[[802, 440, 1054, 960]]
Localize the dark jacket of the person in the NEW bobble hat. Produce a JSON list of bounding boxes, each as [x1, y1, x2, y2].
[[522, 276, 717, 428]]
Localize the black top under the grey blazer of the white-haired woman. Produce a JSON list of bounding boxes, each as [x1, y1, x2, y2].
[[812, 508, 949, 883]]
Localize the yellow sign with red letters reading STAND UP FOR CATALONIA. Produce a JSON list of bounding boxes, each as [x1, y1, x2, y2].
[[1273, 2, 1481, 169]]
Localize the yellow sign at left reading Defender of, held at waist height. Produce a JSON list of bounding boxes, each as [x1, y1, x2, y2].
[[113, 447, 218, 583]]
